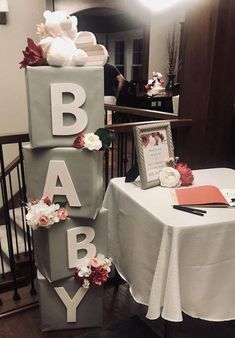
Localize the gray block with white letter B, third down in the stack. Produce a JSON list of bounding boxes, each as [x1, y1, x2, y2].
[[33, 208, 108, 282]]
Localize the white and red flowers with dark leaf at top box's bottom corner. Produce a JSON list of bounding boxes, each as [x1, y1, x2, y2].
[[73, 128, 113, 151]]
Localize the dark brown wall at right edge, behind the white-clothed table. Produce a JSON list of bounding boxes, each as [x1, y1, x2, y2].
[[177, 0, 235, 169]]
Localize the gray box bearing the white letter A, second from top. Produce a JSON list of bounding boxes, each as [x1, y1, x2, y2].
[[23, 144, 104, 218]]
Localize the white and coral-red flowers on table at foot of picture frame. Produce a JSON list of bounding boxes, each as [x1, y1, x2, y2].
[[159, 157, 194, 188]]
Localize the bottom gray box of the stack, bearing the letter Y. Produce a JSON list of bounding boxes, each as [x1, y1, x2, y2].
[[37, 272, 103, 331]]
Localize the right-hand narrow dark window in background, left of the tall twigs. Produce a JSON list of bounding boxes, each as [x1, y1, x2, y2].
[[132, 39, 143, 81]]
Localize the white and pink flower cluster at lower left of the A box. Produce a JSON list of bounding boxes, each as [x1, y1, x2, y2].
[[26, 196, 68, 229]]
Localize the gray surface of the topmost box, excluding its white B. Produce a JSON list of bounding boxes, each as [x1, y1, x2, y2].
[[26, 66, 104, 148]]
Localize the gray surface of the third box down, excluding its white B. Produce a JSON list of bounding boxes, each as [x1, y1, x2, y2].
[[33, 208, 108, 282]]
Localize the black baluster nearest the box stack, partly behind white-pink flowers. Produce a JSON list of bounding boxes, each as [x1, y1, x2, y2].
[[18, 142, 37, 295]]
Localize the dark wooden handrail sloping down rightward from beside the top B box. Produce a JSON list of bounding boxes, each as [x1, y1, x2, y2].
[[104, 104, 178, 120]]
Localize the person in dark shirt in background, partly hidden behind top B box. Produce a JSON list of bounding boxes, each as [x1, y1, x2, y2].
[[104, 63, 125, 124]]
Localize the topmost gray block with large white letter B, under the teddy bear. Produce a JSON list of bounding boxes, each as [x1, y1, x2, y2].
[[26, 66, 104, 148]]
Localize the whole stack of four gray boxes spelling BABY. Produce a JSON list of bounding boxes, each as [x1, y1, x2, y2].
[[23, 66, 107, 331]]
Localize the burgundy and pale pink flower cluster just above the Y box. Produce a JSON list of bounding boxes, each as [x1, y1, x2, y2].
[[74, 254, 112, 289]]
